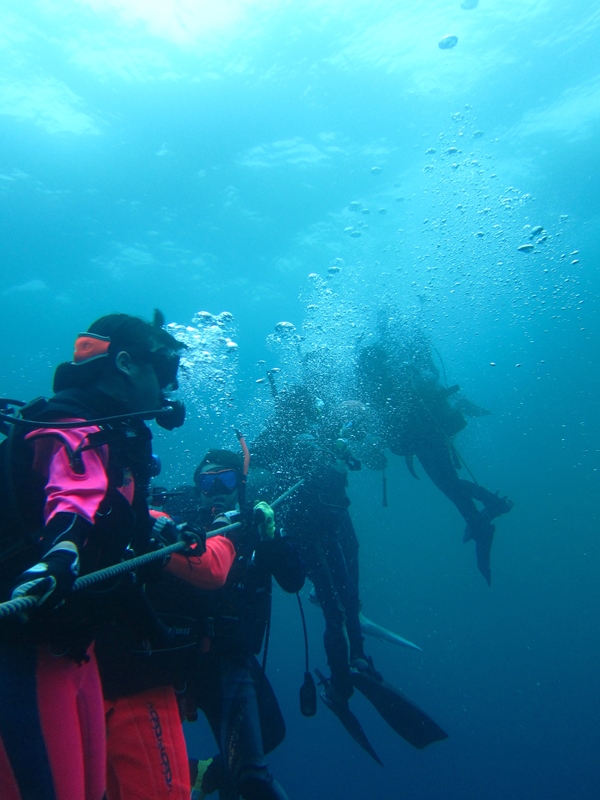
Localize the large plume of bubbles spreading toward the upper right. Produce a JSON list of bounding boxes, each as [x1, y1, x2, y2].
[[259, 101, 585, 406]]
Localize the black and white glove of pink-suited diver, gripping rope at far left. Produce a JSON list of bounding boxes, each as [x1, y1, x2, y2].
[[11, 540, 79, 619]]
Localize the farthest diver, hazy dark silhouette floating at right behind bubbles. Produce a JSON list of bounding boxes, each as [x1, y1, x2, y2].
[[357, 320, 513, 586]]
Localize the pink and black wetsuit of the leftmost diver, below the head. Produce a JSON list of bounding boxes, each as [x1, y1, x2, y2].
[[0, 389, 158, 798]]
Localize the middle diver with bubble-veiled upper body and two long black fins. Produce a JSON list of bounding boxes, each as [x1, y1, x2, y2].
[[250, 385, 446, 763]]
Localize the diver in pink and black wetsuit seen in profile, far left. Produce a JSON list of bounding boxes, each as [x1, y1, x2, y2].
[[0, 312, 185, 800]]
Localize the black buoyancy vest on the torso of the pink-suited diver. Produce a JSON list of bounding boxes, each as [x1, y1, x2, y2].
[[0, 389, 153, 649]]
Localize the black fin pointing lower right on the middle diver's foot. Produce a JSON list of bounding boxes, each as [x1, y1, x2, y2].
[[351, 670, 448, 750]]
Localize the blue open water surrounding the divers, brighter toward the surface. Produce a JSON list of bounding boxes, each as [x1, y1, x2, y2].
[[0, 0, 600, 800]]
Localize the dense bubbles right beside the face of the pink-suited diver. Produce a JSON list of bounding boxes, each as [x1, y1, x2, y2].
[[168, 311, 238, 424]]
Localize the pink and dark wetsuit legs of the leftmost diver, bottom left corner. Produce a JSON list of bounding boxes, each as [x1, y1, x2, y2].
[[0, 645, 106, 800]]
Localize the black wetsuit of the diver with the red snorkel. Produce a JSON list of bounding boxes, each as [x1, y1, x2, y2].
[[166, 505, 305, 800]]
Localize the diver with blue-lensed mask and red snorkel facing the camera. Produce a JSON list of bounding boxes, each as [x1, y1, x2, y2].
[[164, 446, 305, 800]]
